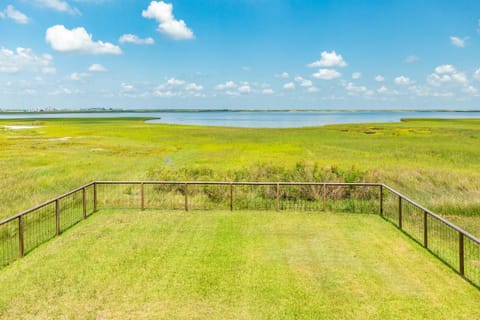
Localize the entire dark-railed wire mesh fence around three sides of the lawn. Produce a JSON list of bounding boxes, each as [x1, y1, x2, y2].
[[0, 181, 480, 287]]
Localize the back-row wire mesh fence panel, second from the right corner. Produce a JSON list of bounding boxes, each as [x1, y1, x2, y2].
[[279, 185, 323, 211]]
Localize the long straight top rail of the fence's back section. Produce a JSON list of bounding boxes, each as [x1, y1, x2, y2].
[[95, 181, 382, 187]]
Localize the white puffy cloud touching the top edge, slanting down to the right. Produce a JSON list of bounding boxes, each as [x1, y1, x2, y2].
[[142, 1, 195, 40]]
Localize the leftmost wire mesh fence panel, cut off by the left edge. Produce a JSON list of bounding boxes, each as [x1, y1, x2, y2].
[[0, 219, 20, 266]]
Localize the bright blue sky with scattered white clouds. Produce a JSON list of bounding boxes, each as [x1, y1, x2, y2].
[[0, 0, 480, 110]]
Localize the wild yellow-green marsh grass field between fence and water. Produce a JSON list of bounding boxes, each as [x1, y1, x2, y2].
[[0, 119, 480, 236]]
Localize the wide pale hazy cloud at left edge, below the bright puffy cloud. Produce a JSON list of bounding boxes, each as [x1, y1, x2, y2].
[[0, 48, 56, 74]]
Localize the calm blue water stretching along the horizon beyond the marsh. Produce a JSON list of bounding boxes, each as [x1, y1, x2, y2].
[[0, 111, 480, 128]]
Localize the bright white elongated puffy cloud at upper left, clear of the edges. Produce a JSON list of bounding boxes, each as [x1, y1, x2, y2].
[[45, 25, 122, 55]]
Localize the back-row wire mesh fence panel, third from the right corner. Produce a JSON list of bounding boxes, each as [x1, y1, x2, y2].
[[233, 185, 277, 210]]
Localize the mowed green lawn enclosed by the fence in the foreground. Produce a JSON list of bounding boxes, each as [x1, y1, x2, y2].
[[0, 210, 480, 319]]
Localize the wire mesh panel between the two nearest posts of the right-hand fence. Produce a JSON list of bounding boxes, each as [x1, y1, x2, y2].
[[427, 215, 459, 271]]
